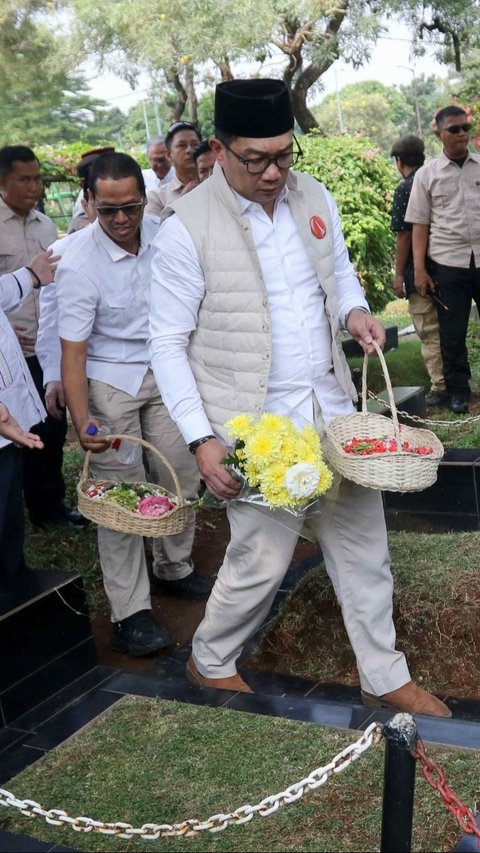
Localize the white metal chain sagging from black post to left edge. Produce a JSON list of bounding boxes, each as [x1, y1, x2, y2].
[[0, 723, 382, 841]]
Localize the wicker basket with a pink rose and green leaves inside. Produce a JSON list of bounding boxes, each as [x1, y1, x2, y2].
[[77, 435, 189, 538]]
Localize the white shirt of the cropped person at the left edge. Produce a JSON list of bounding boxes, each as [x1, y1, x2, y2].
[[0, 268, 46, 448]]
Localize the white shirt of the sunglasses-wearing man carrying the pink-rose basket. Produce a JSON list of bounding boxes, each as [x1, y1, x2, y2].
[[55, 216, 159, 397]]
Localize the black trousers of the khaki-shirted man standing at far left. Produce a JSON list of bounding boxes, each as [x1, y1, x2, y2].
[[22, 356, 67, 524]]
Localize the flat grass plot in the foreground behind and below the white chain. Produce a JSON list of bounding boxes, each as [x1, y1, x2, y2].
[[1, 697, 479, 853]]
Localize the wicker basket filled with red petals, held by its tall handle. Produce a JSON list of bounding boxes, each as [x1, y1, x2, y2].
[[325, 341, 444, 492]]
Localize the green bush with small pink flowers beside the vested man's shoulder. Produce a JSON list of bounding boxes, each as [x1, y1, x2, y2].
[[297, 132, 397, 311]]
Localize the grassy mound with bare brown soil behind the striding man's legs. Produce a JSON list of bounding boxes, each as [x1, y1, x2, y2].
[[252, 532, 480, 699]]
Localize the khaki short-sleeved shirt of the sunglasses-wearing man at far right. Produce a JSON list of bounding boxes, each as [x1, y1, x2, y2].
[[405, 151, 480, 268]]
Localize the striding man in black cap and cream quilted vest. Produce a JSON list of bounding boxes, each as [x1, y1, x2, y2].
[[150, 79, 450, 716]]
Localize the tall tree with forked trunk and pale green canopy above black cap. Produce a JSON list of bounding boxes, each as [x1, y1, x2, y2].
[[63, 0, 480, 131]]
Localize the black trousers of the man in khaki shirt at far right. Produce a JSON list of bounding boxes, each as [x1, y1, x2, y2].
[[434, 260, 480, 399]]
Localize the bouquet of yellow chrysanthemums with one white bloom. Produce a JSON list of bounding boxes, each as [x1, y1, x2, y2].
[[224, 412, 333, 515]]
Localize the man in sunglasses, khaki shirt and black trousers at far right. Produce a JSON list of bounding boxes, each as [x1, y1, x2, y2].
[[405, 106, 480, 415]]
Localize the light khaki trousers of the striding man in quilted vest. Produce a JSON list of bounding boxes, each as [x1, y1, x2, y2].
[[192, 480, 410, 695]]
